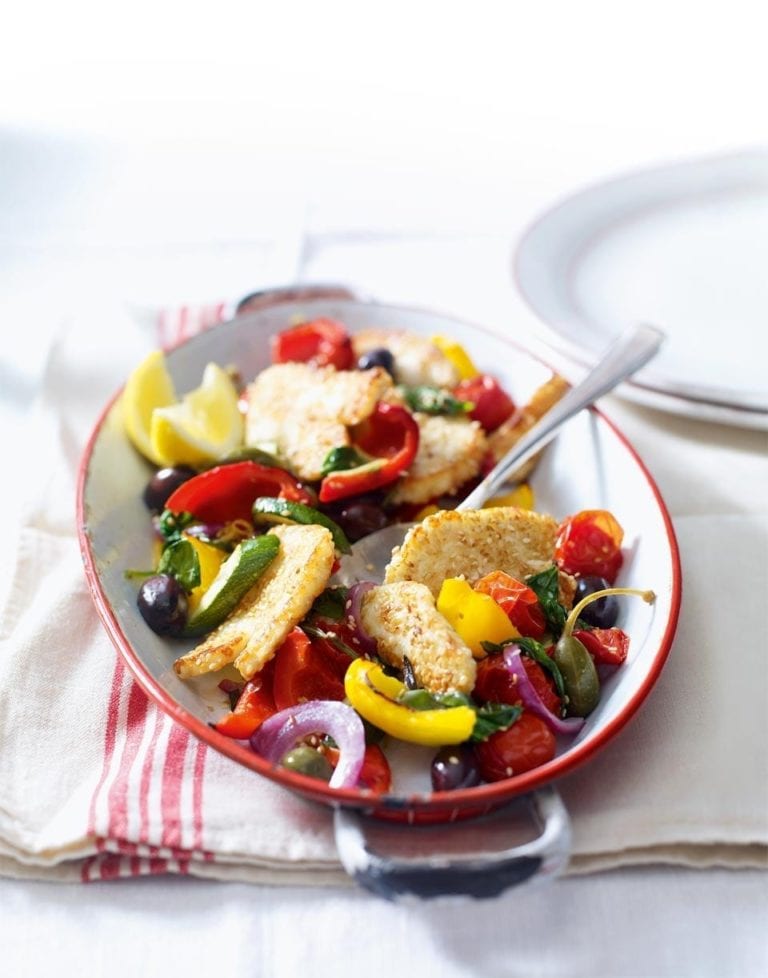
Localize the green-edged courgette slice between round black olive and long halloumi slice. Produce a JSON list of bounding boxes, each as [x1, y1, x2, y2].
[[184, 534, 280, 638]]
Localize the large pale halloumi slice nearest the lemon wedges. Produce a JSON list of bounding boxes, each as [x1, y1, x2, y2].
[[245, 363, 392, 481]]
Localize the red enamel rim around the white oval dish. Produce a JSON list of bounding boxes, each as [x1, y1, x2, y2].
[[77, 300, 682, 820]]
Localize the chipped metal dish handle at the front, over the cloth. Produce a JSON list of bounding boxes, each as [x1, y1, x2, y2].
[[334, 786, 571, 900]]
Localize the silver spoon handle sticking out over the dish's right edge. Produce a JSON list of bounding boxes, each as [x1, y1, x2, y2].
[[456, 325, 664, 510]]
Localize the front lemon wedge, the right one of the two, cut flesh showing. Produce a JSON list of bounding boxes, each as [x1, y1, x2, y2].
[[150, 363, 243, 465]]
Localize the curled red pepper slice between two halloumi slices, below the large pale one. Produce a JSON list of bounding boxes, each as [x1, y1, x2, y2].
[[319, 401, 419, 503]]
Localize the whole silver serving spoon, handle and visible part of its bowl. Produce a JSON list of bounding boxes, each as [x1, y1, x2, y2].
[[335, 326, 664, 584]]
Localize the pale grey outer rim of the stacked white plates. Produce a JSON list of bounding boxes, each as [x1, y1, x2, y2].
[[512, 146, 768, 429]]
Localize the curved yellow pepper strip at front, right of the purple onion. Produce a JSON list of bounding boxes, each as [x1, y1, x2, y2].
[[344, 659, 475, 747]]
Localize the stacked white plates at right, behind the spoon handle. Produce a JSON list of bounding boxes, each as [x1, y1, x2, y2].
[[515, 151, 768, 428]]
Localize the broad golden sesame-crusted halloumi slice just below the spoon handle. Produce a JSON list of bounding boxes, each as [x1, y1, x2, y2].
[[384, 506, 557, 597]]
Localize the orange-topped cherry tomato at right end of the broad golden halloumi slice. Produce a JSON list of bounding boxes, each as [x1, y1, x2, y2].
[[555, 509, 624, 583]]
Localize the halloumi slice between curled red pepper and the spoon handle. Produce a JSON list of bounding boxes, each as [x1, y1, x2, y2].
[[392, 414, 487, 503]]
